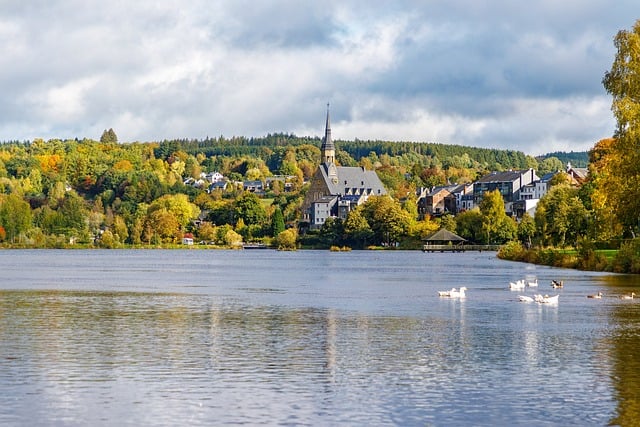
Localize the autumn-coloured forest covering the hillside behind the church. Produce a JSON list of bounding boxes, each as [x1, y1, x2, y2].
[[0, 129, 580, 251]]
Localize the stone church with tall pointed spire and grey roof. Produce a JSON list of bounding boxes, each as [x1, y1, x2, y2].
[[302, 104, 387, 230]]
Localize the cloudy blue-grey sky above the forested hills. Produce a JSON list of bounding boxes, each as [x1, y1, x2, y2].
[[0, 0, 640, 155]]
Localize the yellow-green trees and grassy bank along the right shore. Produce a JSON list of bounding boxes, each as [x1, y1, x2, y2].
[[500, 21, 640, 273]]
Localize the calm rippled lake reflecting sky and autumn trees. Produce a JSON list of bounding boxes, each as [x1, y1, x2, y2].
[[0, 250, 640, 426]]
